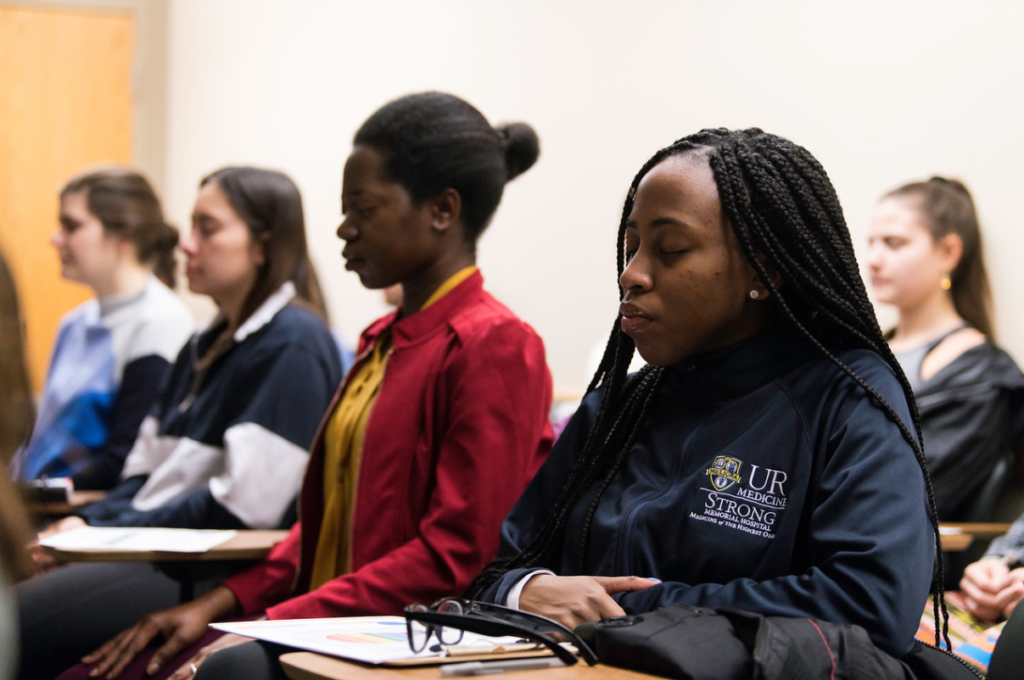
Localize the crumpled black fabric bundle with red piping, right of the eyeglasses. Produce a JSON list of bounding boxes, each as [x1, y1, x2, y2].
[[577, 605, 981, 680]]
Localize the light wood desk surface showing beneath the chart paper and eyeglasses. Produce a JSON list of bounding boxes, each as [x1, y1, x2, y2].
[[281, 651, 653, 680]]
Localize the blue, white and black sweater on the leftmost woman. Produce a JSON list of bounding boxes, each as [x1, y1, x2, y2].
[[11, 275, 195, 488]]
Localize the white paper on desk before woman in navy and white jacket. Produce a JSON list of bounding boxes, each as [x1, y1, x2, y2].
[[39, 526, 238, 553]]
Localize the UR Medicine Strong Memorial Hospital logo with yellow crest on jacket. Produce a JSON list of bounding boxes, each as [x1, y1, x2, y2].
[[690, 456, 787, 539]]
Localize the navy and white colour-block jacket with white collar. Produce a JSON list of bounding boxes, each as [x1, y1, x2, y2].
[[77, 282, 342, 528]]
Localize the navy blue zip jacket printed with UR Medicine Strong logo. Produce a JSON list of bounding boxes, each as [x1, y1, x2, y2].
[[483, 329, 934, 655]]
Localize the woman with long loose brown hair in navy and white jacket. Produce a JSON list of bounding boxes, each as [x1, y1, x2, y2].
[[16, 168, 341, 678]]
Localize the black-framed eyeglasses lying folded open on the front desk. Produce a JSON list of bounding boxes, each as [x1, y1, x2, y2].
[[406, 598, 598, 666]]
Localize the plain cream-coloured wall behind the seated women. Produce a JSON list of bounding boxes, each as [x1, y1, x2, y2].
[[166, 0, 1024, 390]]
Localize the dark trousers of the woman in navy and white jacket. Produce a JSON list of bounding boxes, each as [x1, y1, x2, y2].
[[14, 562, 225, 680]]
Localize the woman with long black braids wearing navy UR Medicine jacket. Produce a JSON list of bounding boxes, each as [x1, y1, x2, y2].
[[469, 129, 941, 656]]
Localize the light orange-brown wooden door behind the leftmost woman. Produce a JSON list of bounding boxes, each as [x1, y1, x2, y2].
[[0, 6, 134, 392]]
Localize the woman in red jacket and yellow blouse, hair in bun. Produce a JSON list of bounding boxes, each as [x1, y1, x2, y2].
[[66, 92, 552, 678]]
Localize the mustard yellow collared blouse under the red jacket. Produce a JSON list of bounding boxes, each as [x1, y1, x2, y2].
[[309, 266, 476, 590]]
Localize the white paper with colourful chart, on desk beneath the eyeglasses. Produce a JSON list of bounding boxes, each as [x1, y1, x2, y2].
[[210, 617, 516, 664]]
